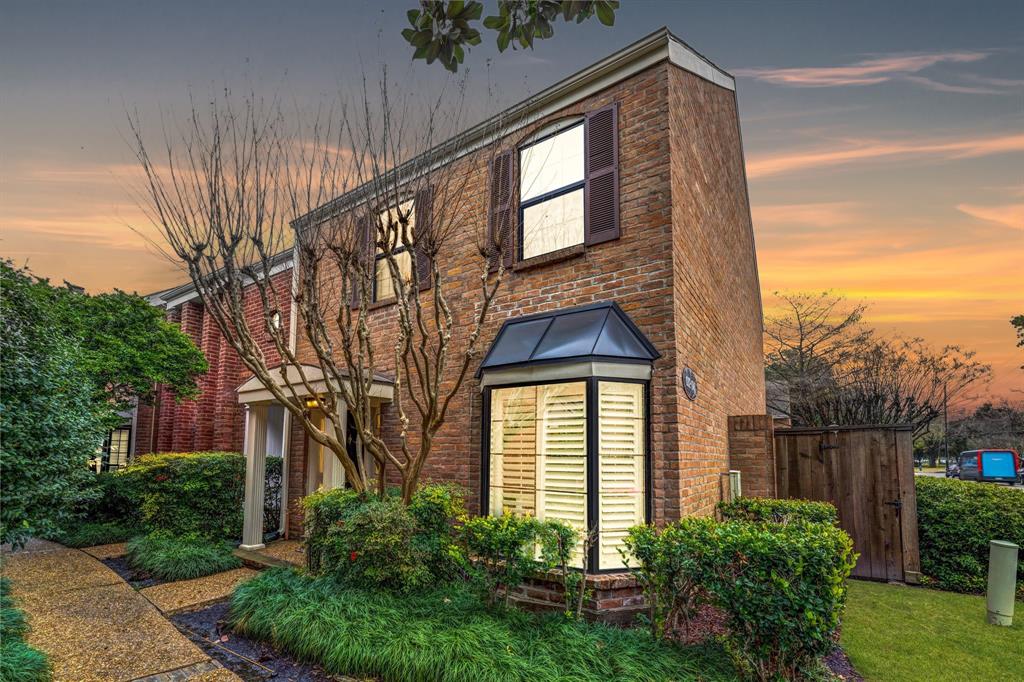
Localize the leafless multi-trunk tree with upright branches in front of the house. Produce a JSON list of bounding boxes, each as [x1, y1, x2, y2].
[[129, 78, 520, 501]]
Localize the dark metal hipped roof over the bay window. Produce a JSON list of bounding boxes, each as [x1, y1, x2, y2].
[[477, 301, 660, 377]]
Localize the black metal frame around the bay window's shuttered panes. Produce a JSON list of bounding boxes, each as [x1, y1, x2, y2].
[[480, 376, 654, 574]]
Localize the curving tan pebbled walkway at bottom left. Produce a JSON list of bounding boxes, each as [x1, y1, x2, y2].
[[2, 540, 239, 682]]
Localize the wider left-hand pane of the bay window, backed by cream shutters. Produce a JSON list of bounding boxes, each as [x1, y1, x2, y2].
[[489, 382, 587, 565]]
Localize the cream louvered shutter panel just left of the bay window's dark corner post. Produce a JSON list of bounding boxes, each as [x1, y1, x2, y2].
[[537, 382, 587, 566]]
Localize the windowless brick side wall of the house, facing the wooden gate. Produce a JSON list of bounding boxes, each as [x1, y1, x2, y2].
[[663, 67, 765, 515]]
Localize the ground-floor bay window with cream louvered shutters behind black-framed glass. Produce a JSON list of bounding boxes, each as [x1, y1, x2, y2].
[[484, 377, 647, 570]]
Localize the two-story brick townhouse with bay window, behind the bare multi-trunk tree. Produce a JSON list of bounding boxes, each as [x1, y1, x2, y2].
[[138, 29, 774, 610]]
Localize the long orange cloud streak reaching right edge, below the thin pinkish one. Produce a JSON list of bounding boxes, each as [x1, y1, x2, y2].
[[746, 134, 1024, 178]]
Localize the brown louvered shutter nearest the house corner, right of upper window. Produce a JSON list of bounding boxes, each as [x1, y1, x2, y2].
[[584, 102, 620, 246]]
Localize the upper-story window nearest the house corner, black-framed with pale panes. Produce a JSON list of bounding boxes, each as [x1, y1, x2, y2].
[[518, 121, 586, 260]]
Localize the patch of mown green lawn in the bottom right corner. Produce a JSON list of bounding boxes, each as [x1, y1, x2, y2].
[[843, 581, 1024, 682]]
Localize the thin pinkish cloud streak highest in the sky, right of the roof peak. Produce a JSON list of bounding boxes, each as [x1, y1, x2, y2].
[[733, 52, 988, 87]]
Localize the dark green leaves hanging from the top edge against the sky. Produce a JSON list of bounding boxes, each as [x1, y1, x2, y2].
[[401, 0, 618, 73]]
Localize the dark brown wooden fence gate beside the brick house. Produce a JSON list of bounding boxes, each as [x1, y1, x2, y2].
[[775, 426, 921, 583]]
